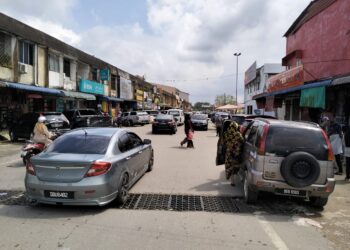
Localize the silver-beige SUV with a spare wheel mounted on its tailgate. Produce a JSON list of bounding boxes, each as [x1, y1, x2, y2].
[[217, 118, 335, 207]]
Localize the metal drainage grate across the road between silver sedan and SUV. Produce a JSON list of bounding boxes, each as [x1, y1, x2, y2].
[[120, 194, 245, 213]]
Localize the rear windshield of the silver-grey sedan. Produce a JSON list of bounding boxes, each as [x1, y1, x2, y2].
[[46, 134, 110, 154]]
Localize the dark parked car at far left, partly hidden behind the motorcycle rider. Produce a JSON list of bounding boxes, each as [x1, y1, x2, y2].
[[9, 112, 70, 141]]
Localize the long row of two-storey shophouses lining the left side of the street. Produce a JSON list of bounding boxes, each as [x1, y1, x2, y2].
[[0, 13, 191, 129]]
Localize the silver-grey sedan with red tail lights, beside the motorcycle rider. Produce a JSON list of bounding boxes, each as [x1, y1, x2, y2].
[[25, 128, 154, 206]]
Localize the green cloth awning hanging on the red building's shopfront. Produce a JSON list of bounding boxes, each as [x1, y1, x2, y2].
[[300, 86, 326, 109]]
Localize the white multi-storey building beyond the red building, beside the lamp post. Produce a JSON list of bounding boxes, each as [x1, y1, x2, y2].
[[244, 62, 285, 116]]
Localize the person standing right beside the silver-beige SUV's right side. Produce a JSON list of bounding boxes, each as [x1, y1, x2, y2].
[[328, 119, 343, 175]]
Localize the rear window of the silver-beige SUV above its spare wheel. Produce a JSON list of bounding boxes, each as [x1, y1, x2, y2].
[[266, 127, 328, 160]]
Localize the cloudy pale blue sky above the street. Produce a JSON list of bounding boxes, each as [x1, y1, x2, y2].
[[0, 0, 311, 103]]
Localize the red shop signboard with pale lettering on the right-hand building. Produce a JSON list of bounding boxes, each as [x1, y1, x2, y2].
[[267, 66, 304, 93]]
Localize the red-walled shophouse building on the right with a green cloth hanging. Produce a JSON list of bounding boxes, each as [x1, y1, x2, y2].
[[254, 0, 350, 124]]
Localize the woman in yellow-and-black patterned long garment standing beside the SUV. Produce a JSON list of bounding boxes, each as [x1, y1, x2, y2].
[[224, 122, 244, 186]]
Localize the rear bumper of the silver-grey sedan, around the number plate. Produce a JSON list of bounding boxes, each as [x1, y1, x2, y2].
[[25, 174, 118, 206]]
